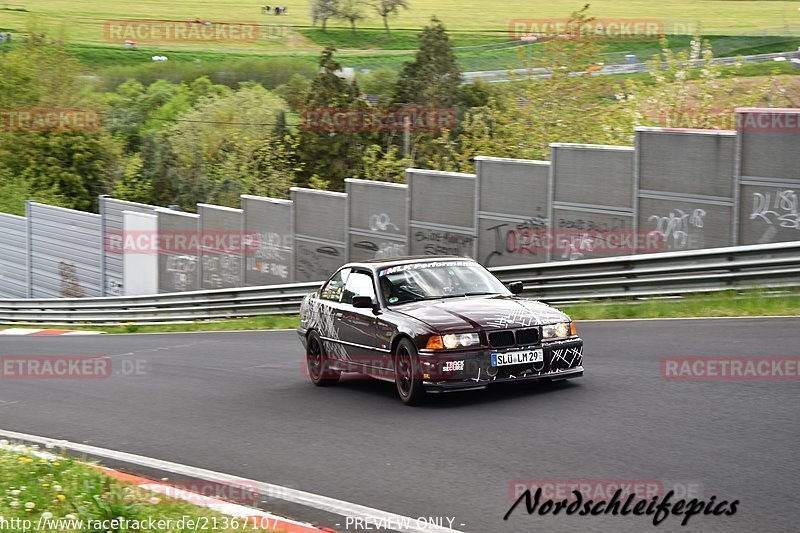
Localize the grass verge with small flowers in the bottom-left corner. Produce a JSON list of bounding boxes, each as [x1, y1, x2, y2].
[[0, 441, 272, 533]]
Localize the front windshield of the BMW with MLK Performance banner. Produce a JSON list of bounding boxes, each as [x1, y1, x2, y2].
[[378, 261, 511, 305]]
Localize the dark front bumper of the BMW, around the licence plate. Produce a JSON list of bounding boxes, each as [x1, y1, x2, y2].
[[420, 338, 584, 392]]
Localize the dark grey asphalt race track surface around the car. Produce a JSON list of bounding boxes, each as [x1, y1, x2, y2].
[[0, 318, 800, 532]]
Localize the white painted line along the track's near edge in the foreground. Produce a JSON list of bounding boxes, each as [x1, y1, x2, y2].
[[0, 429, 461, 533]]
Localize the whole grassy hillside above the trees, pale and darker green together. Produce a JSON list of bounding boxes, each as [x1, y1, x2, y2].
[[0, 0, 800, 77]]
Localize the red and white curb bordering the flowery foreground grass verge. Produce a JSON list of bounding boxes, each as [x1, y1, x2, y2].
[[100, 467, 330, 533]]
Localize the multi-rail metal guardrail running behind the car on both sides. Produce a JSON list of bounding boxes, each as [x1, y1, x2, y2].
[[0, 241, 800, 326]]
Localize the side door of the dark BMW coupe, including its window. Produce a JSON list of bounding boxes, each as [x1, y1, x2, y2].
[[336, 270, 378, 370]]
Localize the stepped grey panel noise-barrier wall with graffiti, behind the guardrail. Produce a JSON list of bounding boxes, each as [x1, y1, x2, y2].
[[0, 108, 800, 299]]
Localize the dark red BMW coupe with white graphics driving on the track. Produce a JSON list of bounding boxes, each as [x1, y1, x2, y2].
[[297, 257, 583, 404]]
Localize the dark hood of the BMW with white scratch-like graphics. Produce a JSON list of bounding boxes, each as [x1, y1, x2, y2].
[[394, 296, 569, 332]]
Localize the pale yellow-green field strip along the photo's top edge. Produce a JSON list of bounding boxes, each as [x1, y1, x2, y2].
[[0, 0, 800, 49]]
